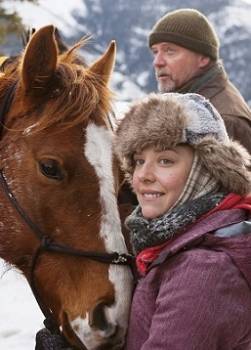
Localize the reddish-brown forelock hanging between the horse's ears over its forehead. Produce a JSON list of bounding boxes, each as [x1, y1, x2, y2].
[[32, 62, 111, 129]]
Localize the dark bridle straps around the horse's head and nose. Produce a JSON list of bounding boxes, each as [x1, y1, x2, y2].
[[0, 82, 135, 344]]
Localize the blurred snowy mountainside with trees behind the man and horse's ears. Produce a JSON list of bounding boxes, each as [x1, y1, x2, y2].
[[0, 0, 251, 105]]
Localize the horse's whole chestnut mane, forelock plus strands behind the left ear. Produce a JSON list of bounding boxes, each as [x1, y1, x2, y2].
[[0, 40, 112, 132]]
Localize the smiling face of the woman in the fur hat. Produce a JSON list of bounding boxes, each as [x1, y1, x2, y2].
[[132, 145, 194, 219]]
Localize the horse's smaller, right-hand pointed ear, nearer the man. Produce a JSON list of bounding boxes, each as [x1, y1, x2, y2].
[[89, 40, 116, 83]]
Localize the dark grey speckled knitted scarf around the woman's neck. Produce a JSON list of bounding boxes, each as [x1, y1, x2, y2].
[[125, 192, 226, 254]]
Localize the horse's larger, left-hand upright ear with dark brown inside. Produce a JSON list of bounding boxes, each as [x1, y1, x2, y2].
[[21, 25, 58, 95]]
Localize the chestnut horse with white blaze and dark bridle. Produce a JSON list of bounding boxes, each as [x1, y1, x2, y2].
[[0, 25, 133, 350]]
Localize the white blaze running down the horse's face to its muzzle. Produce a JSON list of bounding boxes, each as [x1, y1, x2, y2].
[[71, 123, 132, 349]]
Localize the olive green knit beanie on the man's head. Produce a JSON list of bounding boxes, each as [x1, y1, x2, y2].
[[149, 9, 220, 60]]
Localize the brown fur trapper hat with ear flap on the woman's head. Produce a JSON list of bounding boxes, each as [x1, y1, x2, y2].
[[114, 93, 251, 195]]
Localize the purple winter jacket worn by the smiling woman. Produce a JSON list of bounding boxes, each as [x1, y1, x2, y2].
[[126, 209, 251, 350]]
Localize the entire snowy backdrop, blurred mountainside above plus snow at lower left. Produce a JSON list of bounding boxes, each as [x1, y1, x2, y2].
[[0, 0, 251, 350]]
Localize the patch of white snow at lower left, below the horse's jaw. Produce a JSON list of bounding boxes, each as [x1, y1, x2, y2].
[[0, 259, 43, 350]]
